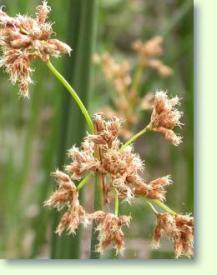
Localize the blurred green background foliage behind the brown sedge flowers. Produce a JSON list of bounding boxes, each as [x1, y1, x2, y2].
[[0, 0, 194, 259]]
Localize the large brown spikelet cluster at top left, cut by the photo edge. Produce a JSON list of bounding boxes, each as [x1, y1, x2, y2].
[[0, 1, 71, 97]]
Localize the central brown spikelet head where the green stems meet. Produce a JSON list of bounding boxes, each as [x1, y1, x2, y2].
[[65, 114, 146, 201]]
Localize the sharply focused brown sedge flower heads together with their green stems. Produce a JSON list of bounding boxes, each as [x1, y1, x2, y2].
[[0, 1, 194, 258]]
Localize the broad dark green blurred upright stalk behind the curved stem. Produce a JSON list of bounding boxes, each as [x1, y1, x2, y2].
[[52, 0, 96, 259]]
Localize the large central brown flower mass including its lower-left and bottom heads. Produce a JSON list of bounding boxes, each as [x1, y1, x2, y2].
[[45, 114, 179, 253]]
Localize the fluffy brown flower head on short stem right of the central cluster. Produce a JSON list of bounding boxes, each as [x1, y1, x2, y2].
[[148, 91, 182, 145]]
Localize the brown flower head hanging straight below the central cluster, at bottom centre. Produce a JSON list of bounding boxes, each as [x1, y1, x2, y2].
[[91, 211, 131, 254]]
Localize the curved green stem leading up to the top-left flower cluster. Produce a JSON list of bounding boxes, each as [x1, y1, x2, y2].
[[47, 61, 94, 132]]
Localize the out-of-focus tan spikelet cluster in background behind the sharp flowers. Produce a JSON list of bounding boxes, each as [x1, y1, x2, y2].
[[93, 36, 173, 139]]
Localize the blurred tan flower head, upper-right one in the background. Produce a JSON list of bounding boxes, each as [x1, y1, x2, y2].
[[133, 36, 173, 77]]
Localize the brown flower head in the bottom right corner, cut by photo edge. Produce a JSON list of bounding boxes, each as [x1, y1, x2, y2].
[[153, 213, 194, 258]]
